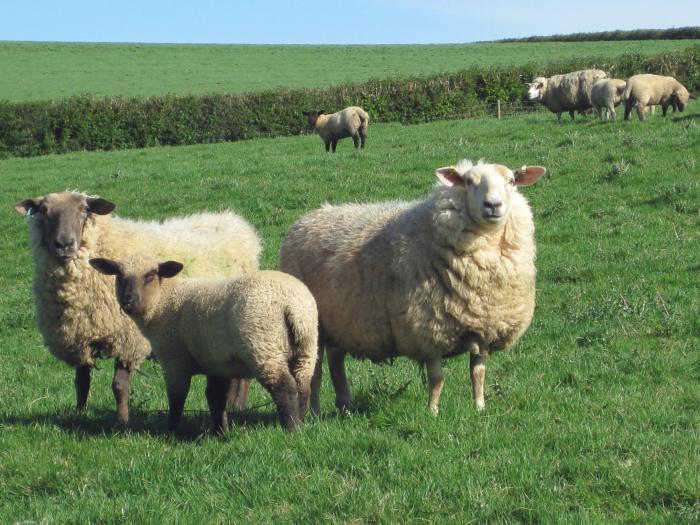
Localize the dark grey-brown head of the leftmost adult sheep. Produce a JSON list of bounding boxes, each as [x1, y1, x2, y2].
[[14, 191, 115, 263]]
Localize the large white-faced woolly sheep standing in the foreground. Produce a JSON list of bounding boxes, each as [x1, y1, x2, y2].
[[280, 160, 546, 414]]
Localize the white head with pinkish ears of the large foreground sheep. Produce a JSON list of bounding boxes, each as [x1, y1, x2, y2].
[[435, 159, 546, 229]]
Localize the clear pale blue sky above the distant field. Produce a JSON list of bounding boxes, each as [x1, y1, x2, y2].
[[0, 0, 700, 44]]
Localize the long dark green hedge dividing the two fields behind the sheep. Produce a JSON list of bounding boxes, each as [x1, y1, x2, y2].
[[0, 46, 700, 157]]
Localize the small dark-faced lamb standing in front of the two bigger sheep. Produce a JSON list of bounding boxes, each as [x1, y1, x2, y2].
[[90, 255, 318, 433]]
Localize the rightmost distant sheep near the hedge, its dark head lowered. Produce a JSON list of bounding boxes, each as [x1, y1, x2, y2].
[[622, 73, 690, 121]]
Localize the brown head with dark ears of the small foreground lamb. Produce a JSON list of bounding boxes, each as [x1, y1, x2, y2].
[[90, 256, 183, 318]]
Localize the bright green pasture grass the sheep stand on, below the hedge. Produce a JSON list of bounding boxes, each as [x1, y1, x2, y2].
[[0, 108, 700, 524]]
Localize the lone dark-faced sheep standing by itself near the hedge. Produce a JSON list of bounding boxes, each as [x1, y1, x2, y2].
[[304, 106, 369, 153]]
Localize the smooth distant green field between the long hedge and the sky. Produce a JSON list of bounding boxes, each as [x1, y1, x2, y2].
[[0, 40, 700, 102]]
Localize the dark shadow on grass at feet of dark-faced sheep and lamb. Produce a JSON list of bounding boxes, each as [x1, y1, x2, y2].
[[0, 408, 288, 442]]
